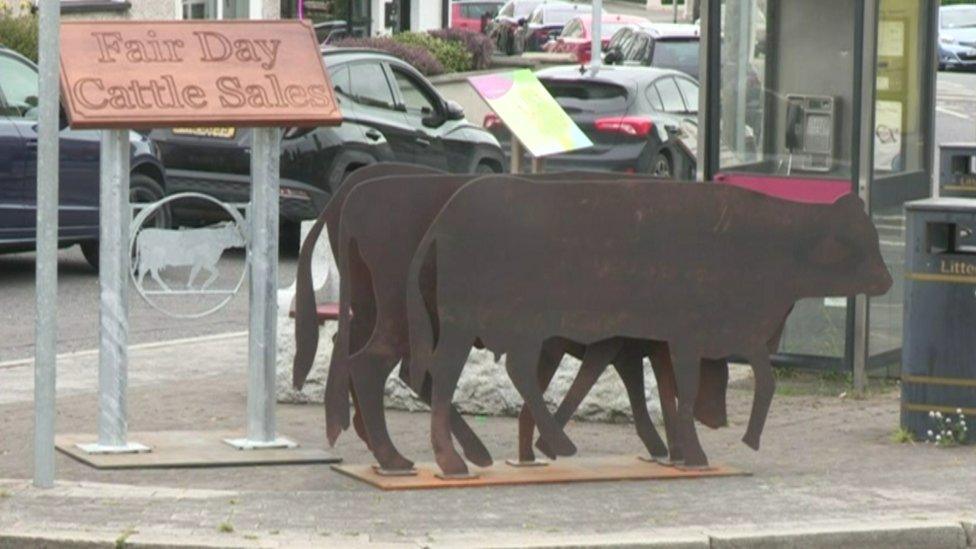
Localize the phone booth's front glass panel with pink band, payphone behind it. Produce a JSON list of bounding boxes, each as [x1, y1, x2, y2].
[[712, 0, 861, 359]]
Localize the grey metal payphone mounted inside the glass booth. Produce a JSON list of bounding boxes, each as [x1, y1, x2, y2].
[[784, 94, 838, 174]]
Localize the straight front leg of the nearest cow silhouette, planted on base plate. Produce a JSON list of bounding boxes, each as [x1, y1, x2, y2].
[[671, 342, 708, 469]]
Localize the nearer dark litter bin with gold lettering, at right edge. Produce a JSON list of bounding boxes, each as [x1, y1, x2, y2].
[[901, 198, 976, 442]]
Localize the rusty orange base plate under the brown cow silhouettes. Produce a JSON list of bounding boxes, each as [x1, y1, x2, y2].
[[332, 456, 749, 490]]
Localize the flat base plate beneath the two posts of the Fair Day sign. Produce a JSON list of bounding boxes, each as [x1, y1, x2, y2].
[[55, 431, 342, 469]]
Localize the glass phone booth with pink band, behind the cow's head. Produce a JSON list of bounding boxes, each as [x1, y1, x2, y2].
[[699, 0, 939, 377]]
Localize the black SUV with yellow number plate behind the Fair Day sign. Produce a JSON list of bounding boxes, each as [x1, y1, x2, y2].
[[151, 47, 505, 232]]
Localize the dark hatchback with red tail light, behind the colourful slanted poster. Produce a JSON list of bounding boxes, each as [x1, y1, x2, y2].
[[484, 66, 698, 179]]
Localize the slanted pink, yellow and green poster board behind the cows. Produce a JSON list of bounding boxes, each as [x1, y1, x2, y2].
[[468, 69, 593, 158]]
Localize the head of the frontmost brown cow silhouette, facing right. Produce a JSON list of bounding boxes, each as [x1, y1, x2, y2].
[[797, 195, 892, 297]]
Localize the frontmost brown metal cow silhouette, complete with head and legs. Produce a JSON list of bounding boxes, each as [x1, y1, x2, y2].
[[407, 176, 892, 476]]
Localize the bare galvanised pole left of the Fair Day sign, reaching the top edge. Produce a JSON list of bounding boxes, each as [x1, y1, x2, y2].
[[34, 0, 61, 488]]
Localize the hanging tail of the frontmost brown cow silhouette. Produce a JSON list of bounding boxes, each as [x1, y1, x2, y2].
[[407, 234, 440, 393]]
